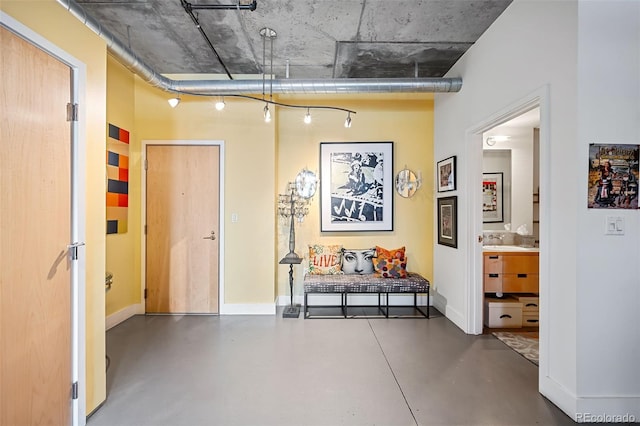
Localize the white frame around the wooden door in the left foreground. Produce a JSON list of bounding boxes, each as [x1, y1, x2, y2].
[[0, 11, 87, 426]]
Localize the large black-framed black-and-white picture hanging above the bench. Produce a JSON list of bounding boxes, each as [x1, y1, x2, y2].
[[320, 142, 393, 232]]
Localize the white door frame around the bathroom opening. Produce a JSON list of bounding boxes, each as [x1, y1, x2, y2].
[[465, 85, 551, 377]]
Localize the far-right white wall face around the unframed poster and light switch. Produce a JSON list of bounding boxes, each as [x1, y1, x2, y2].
[[574, 0, 640, 421]]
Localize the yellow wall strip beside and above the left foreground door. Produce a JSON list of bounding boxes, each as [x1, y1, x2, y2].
[[0, 0, 106, 412]]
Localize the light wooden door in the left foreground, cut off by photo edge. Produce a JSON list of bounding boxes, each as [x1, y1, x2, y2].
[[0, 27, 72, 425]]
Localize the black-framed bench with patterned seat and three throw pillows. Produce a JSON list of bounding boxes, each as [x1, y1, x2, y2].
[[303, 245, 429, 318]]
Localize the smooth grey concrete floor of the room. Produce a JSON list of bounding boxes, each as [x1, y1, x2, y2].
[[88, 309, 574, 426]]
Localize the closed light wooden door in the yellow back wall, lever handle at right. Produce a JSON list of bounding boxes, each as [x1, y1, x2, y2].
[[146, 145, 220, 314]]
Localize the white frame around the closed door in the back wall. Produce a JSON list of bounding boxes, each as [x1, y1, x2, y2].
[[140, 139, 225, 315]]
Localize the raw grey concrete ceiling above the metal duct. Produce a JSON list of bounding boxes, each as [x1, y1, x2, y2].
[[77, 0, 512, 79]]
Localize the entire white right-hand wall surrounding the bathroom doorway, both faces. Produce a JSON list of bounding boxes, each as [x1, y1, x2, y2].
[[434, 0, 640, 420]]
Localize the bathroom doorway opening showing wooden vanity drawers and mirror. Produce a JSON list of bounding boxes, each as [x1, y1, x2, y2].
[[481, 107, 540, 342]]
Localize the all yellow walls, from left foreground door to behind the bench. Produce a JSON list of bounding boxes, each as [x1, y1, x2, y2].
[[0, 0, 434, 412]]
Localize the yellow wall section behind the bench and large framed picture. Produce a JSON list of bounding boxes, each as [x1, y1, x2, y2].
[[277, 94, 434, 295]]
